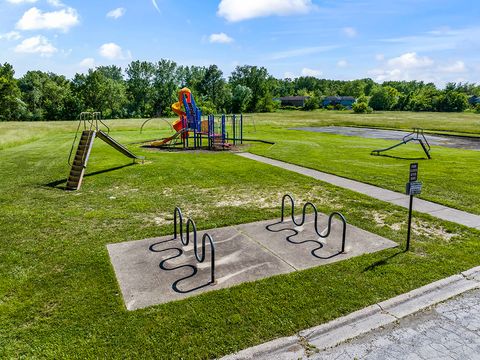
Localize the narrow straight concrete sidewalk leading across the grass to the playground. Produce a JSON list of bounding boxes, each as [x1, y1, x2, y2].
[[237, 153, 480, 229]]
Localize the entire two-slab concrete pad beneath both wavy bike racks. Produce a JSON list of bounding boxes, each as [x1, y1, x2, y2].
[[107, 214, 397, 310]]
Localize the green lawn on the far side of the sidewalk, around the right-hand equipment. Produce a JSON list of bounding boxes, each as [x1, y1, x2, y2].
[[250, 111, 480, 214]]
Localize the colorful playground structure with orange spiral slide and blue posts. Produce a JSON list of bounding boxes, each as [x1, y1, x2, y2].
[[150, 88, 243, 150]]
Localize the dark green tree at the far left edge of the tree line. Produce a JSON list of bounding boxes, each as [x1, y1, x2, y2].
[[0, 63, 23, 120]]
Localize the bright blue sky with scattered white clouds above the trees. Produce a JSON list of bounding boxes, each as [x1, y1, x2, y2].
[[0, 0, 480, 87]]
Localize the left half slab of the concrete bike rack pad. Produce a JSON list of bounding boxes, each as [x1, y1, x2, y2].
[[107, 227, 294, 310]]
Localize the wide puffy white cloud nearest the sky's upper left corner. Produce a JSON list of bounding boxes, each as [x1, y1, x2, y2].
[[16, 7, 80, 31]]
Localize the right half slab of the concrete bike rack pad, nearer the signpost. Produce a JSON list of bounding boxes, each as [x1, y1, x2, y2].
[[236, 214, 398, 270]]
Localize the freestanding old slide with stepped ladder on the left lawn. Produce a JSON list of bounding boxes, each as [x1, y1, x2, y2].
[[67, 112, 144, 190]]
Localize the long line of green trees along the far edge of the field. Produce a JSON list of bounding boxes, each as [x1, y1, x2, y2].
[[0, 59, 480, 120]]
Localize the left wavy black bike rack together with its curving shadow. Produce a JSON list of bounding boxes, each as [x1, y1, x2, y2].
[[149, 207, 216, 294]]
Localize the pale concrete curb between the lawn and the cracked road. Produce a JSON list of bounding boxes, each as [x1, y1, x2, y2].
[[222, 266, 480, 360]]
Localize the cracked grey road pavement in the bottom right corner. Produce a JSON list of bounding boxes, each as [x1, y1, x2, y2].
[[309, 290, 480, 360]]
